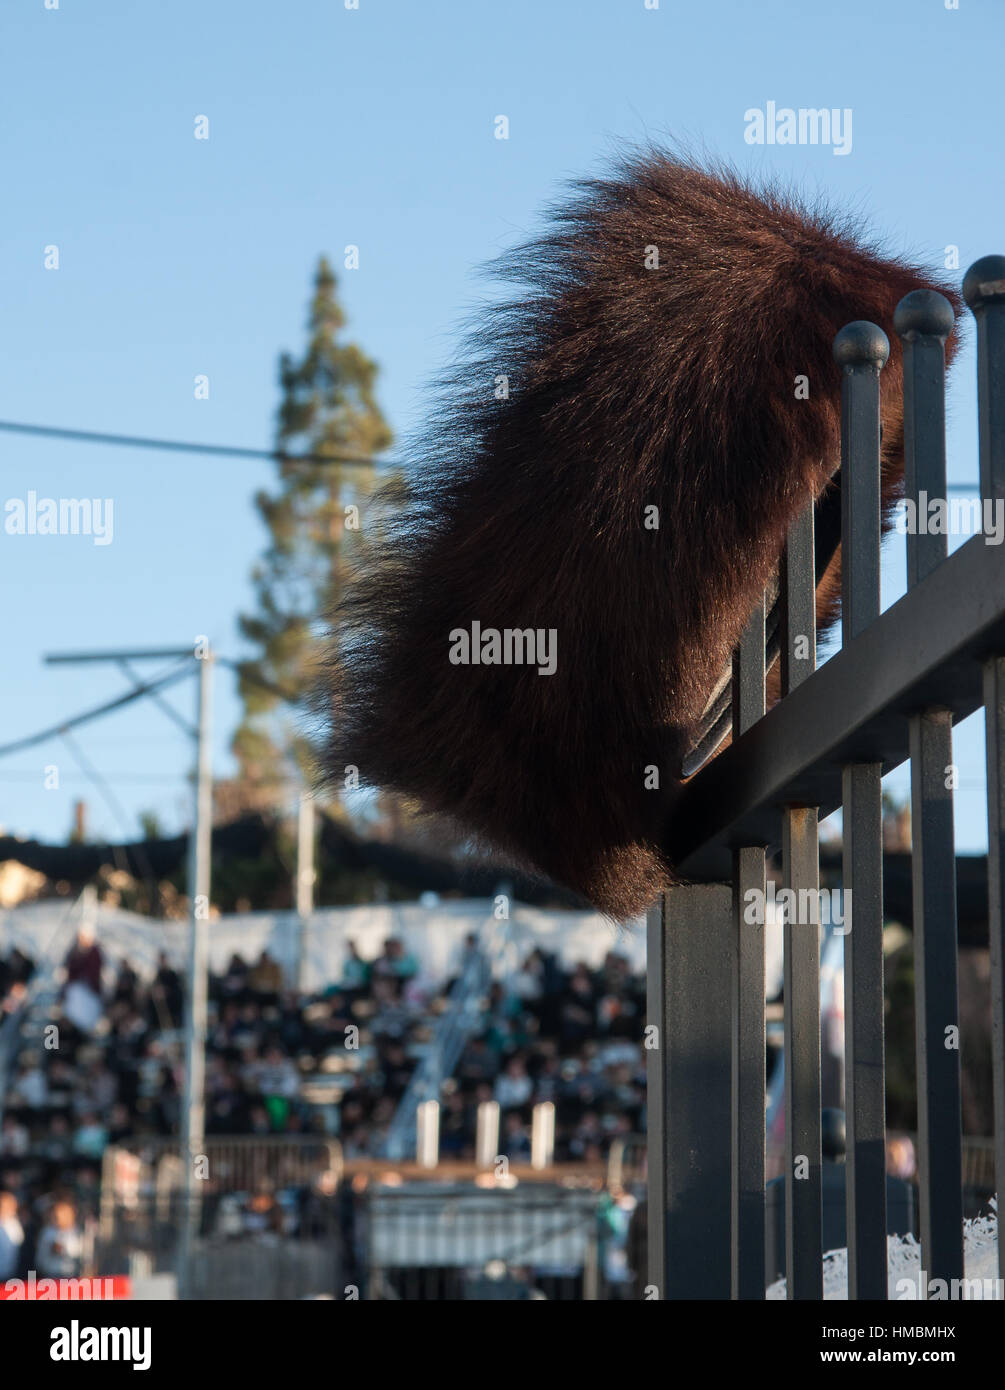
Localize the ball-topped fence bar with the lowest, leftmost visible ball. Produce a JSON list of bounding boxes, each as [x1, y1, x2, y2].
[[834, 322, 889, 1300]]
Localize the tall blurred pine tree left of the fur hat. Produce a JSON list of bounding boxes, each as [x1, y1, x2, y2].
[[232, 257, 391, 802]]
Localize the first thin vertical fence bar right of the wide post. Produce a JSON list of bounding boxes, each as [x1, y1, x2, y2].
[[731, 595, 766, 1298]]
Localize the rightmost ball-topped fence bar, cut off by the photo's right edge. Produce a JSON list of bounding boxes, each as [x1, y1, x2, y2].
[[963, 256, 1005, 1279]]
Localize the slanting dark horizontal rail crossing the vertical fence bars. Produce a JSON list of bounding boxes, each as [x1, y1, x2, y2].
[[666, 535, 1005, 878]]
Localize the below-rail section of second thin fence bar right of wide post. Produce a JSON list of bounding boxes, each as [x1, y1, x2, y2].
[[781, 806, 823, 1298]]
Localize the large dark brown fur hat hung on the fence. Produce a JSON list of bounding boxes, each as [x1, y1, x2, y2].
[[325, 152, 959, 919]]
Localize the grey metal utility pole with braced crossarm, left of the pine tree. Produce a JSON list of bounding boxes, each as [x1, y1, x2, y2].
[[46, 638, 214, 1298]]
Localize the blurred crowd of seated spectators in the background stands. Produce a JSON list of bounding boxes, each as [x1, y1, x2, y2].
[[0, 929, 645, 1279]]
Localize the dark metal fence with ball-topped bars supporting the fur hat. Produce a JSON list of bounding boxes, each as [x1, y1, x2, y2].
[[648, 256, 1005, 1298]]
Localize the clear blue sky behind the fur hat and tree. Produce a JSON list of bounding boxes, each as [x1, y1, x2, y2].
[[0, 0, 1005, 849]]
